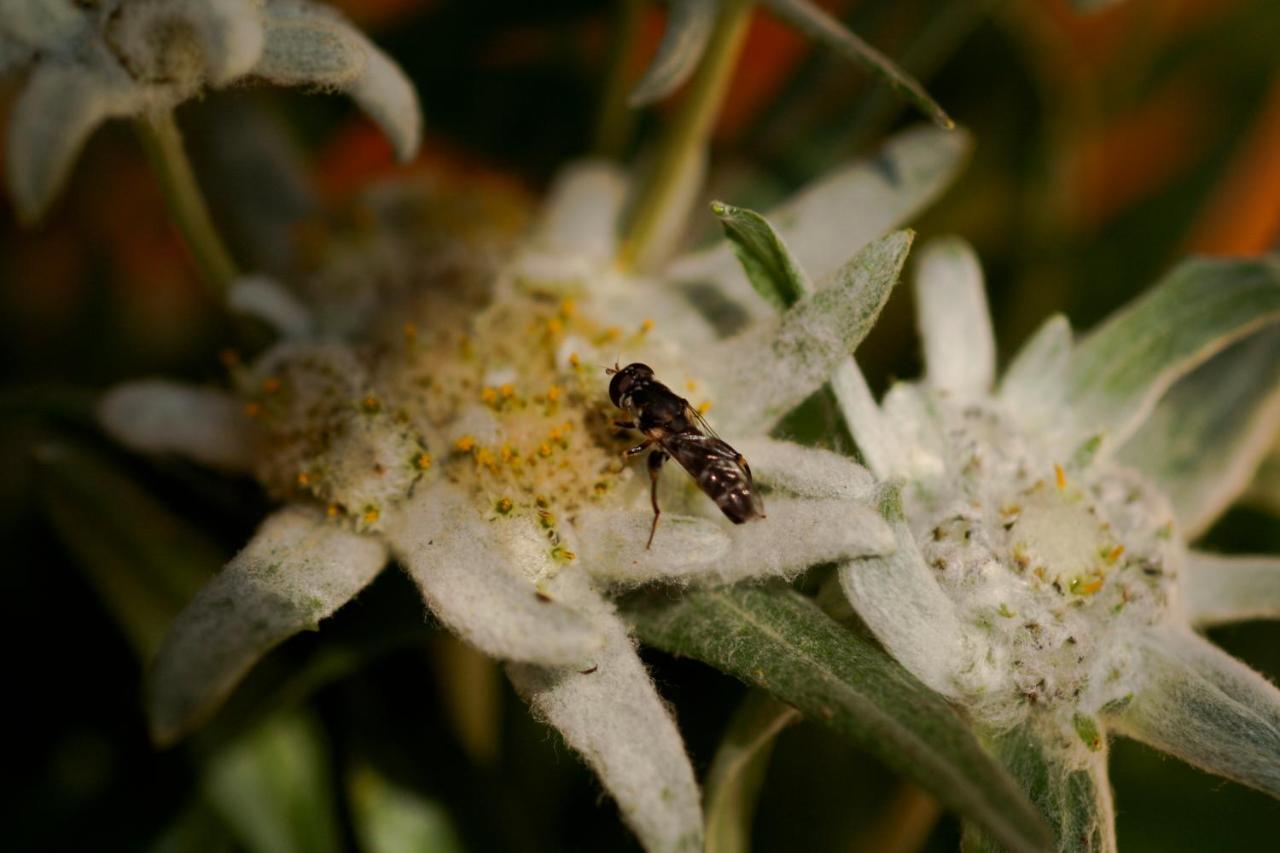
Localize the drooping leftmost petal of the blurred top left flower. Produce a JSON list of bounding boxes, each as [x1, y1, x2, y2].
[[6, 61, 148, 224]]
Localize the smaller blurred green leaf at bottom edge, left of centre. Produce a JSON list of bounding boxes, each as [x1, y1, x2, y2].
[[347, 767, 463, 853]]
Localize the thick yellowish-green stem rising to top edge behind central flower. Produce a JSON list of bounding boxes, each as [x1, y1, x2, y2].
[[618, 0, 753, 269]]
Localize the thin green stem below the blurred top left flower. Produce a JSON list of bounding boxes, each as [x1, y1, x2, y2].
[[134, 110, 239, 301]]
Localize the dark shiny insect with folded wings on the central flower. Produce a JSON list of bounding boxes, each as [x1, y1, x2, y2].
[[604, 362, 764, 549]]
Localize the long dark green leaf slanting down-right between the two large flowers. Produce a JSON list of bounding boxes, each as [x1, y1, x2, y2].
[[627, 587, 1048, 850]]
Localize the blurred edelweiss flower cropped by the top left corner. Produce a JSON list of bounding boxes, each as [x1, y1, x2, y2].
[[0, 0, 421, 222]]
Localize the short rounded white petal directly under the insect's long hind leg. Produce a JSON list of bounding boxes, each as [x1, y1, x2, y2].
[[573, 510, 730, 584]]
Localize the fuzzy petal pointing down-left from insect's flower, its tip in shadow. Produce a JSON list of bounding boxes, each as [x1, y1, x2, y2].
[[148, 507, 387, 743]]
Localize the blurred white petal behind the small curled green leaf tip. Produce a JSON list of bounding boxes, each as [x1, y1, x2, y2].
[[667, 126, 970, 318]]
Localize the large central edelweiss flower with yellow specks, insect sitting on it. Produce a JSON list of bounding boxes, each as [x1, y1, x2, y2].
[[102, 131, 964, 849]]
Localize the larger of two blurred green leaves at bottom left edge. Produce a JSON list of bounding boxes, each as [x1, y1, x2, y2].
[[204, 712, 342, 853]]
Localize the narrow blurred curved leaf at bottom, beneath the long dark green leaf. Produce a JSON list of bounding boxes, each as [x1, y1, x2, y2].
[[704, 690, 800, 853]]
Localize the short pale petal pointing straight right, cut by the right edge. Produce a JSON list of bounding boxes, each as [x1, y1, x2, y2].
[[1181, 551, 1280, 626]]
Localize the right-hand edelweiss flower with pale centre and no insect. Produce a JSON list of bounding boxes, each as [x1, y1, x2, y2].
[[814, 235, 1280, 849]]
